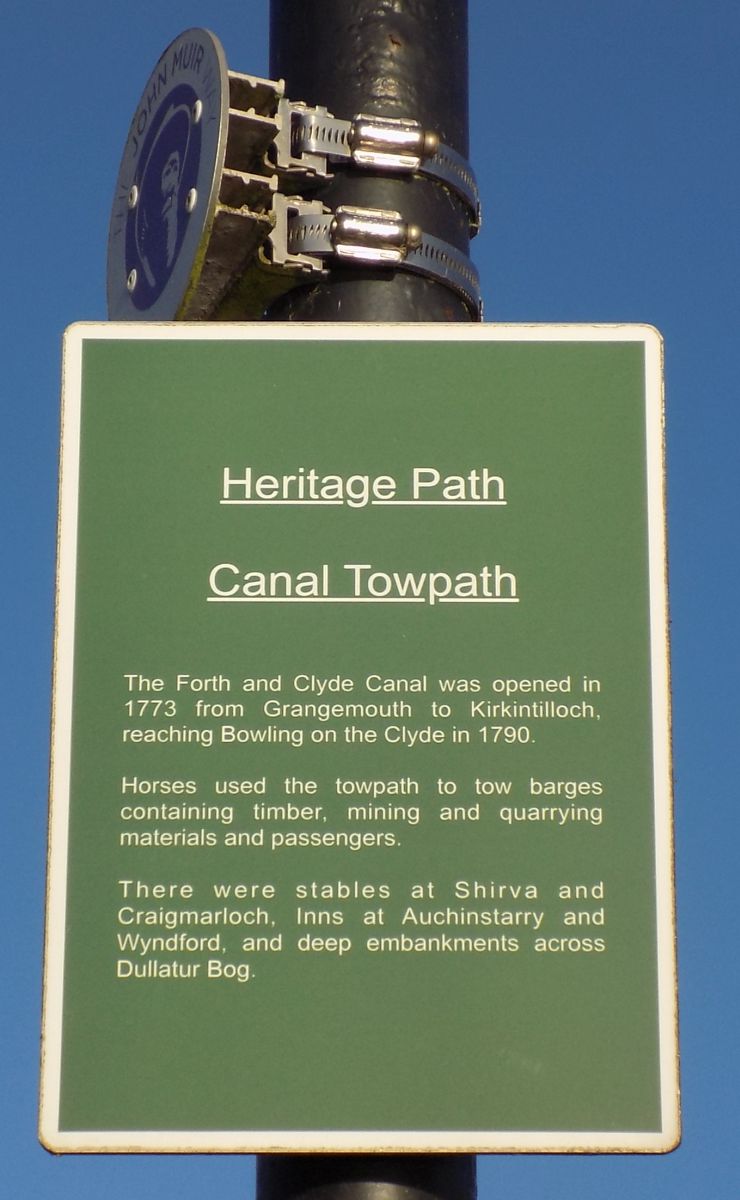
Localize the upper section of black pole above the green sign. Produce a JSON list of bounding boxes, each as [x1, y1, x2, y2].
[[267, 0, 470, 322]]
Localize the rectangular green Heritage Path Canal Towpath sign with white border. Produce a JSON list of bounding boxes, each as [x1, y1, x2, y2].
[[42, 324, 678, 1152]]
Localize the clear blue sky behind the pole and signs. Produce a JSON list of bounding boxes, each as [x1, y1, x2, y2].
[[0, 0, 740, 1200]]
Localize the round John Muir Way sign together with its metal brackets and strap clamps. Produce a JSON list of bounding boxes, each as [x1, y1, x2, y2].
[[108, 29, 481, 320]]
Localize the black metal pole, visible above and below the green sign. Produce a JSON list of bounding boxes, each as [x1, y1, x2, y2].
[[257, 0, 476, 1200]]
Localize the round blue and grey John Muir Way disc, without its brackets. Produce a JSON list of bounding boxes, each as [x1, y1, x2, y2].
[[108, 29, 229, 320]]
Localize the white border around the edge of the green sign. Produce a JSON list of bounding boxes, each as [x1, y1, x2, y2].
[[40, 322, 680, 1154]]
